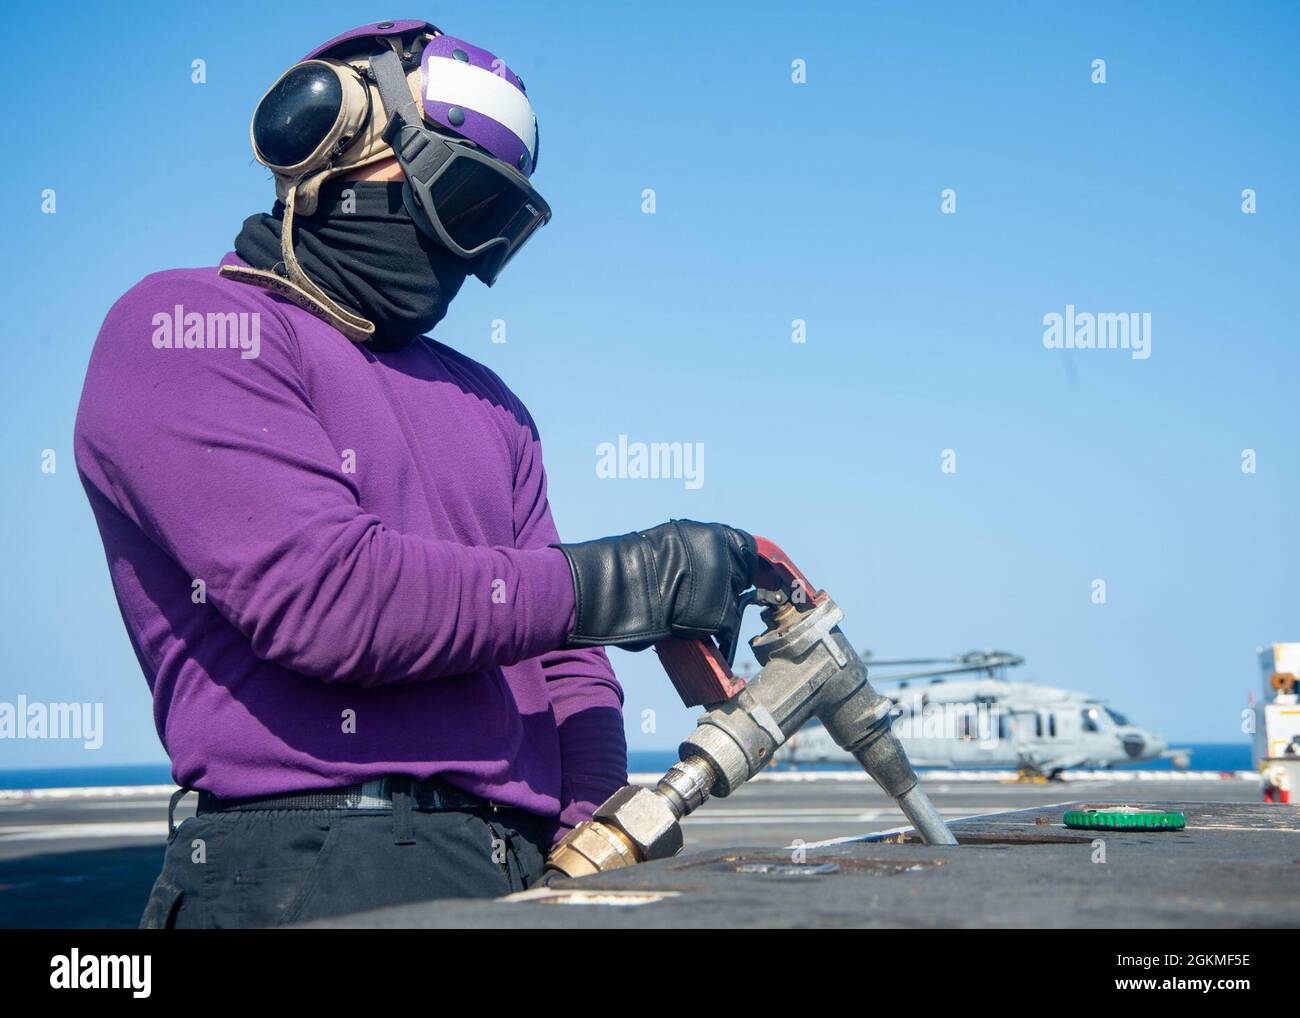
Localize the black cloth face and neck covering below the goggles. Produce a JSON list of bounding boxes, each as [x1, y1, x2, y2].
[[235, 181, 471, 350]]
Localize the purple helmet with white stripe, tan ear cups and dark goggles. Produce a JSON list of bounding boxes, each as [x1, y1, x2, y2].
[[251, 21, 551, 310]]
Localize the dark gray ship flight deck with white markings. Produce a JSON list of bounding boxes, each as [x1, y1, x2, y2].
[[0, 771, 1284, 927]]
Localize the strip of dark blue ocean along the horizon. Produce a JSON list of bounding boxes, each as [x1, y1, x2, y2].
[[0, 742, 1253, 790]]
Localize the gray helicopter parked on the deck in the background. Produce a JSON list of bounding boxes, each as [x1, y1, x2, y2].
[[775, 650, 1191, 777]]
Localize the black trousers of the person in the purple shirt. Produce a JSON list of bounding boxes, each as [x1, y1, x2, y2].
[[140, 803, 554, 930]]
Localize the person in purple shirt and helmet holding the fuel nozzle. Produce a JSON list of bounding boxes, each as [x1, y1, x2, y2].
[[75, 21, 754, 927]]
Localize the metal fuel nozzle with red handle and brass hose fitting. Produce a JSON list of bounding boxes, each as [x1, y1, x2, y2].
[[547, 538, 957, 876]]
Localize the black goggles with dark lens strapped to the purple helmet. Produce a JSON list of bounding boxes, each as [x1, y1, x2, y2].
[[384, 117, 551, 286]]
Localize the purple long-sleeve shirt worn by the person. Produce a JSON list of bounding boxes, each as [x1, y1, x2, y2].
[[75, 255, 627, 829]]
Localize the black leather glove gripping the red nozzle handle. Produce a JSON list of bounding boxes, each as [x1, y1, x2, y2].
[[555, 520, 758, 650]]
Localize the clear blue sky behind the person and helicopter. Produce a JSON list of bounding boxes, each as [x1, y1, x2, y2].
[[0, 3, 1300, 767]]
